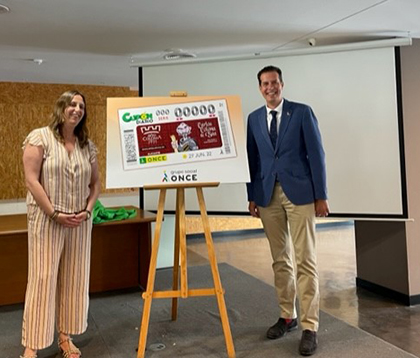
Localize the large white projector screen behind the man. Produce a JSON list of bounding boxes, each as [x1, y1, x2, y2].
[[142, 47, 407, 218]]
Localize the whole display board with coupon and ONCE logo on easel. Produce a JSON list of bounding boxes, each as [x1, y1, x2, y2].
[[106, 96, 249, 188]]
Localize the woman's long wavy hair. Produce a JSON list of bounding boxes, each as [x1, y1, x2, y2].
[[49, 90, 89, 148]]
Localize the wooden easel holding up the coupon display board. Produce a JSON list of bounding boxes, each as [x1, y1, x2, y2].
[[137, 183, 235, 358]]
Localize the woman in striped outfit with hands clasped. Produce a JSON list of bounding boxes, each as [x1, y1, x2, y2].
[[21, 91, 100, 358]]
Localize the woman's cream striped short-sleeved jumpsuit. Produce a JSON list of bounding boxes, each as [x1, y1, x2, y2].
[[22, 127, 96, 350]]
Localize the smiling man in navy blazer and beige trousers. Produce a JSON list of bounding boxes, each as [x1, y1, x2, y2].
[[247, 66, 329, 356]]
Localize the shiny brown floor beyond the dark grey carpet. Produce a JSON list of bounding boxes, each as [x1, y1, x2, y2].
[[188, 223, 420, 357]]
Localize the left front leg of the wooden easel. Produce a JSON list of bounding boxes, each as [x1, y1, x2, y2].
[[137, 189, 166, 358]]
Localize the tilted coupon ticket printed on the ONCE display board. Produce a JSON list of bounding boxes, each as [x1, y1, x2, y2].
[[118, 99, 236, 170]]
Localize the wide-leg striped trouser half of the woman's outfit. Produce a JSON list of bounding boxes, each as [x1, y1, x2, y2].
[[22, 205, 92, 350]]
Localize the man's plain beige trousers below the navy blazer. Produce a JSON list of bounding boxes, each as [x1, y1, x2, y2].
[[258, 185, 319, 331]]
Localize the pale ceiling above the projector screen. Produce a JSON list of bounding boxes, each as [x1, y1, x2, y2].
[[0, 0, 420, 88]]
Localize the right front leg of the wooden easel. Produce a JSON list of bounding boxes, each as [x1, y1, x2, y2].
[[197, 187, 235, 358]]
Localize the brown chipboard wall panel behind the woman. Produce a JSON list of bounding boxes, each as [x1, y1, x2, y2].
[[0, 82, 137, 200]]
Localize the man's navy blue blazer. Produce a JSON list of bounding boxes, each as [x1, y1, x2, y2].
[[247, 99, 327, 207]]
